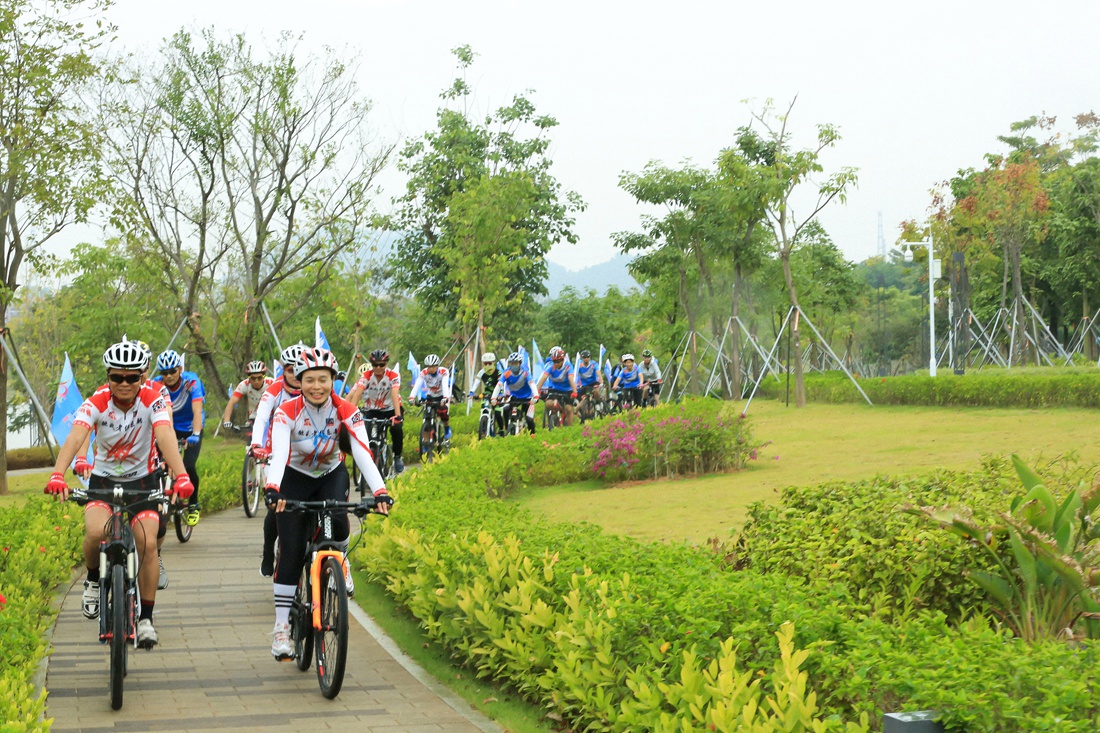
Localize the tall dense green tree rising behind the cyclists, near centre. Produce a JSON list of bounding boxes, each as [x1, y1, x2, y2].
[[389, 46, 584, 347]]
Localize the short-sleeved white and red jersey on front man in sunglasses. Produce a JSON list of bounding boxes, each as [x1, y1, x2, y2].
[[73, 384, 172, 481]]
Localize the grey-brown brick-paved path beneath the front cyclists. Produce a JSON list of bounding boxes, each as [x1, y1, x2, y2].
[[46, 508, 499, 733]]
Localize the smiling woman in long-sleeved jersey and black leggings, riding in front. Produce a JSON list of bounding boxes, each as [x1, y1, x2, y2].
[[264, 348, 392, 661]]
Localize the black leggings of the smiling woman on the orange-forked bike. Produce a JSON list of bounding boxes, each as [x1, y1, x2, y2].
[[275, 463, 351, 586]]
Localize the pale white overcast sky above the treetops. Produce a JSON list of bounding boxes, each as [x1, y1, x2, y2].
[[110, 0, 1100, 270]]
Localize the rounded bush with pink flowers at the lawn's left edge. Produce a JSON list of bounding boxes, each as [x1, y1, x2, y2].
[[582, 400, 761, 481]]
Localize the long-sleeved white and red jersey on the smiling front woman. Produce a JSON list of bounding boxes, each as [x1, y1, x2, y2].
[[267, 392, 386, 493]]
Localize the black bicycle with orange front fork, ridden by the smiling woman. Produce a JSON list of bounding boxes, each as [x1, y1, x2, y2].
[[284, 496, 392, 700]]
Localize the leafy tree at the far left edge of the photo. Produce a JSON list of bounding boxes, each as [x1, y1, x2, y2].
[[0, 0, 112, 494]]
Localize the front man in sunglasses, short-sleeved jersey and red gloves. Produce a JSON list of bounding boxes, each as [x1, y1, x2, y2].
[[46, 341, 195, 648]]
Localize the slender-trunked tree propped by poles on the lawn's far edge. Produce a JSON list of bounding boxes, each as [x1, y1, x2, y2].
[[736, 99, 857, 407]]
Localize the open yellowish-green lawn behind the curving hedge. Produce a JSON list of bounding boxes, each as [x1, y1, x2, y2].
[[517, 400, 1100, 543]]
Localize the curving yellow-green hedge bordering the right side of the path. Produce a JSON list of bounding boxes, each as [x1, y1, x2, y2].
[[359, 406, 1100, 733]]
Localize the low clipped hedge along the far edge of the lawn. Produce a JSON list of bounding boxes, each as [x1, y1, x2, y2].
[[759, 367, 1100, 408]]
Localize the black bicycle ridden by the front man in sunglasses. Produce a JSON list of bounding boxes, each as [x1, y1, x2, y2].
[[73, 484, 164, 710]]
